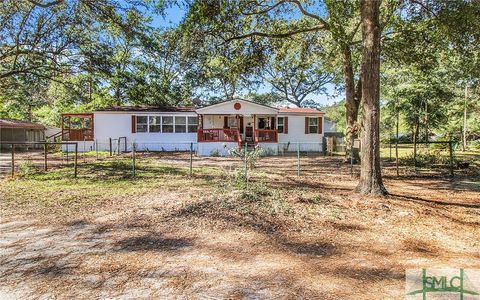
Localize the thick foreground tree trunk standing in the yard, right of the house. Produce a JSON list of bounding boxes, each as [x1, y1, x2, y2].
[[357, 0, 387, 195]]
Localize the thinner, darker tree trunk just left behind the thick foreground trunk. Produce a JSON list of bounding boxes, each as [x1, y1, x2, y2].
[[342, 45, 360, 161]]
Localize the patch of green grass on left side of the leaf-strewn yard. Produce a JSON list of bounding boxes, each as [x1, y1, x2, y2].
[[0, 158, 221, 217]]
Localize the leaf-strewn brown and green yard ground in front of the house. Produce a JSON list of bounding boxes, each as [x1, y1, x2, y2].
[[0, 154, 480, 299]]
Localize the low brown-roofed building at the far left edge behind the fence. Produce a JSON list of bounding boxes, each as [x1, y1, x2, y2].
[[0, 119, 45, 149]]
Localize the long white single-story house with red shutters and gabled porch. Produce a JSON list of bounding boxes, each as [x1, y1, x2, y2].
[[62, 99, 324, 156]]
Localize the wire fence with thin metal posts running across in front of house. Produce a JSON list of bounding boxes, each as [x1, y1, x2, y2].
[[0, 138, 472, 180]]
